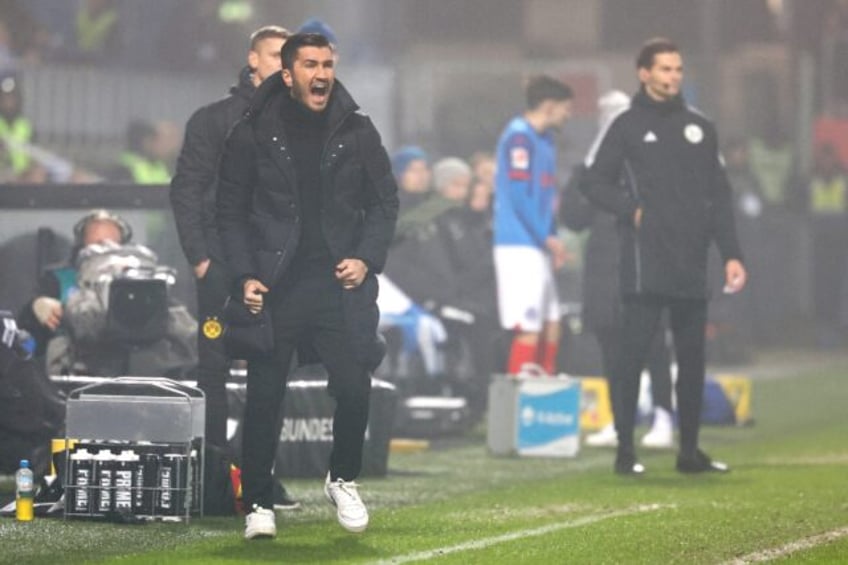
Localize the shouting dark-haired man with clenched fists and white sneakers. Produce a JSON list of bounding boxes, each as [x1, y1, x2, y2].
[[217, 33, 398, 539]]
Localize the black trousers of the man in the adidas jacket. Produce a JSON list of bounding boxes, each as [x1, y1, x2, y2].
[[612, 295, 707, 455]]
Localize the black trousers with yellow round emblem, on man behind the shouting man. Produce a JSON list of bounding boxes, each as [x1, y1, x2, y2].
[[197, 260, 231, 449]]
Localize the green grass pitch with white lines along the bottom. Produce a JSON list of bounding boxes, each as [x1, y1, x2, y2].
[[0, 354, 848, 564]]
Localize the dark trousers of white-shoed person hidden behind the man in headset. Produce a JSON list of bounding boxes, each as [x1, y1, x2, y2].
[[594, 318, 672, 413]]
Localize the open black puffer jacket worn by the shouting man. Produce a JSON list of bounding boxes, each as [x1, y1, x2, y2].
[[212, 73, 398, 364]]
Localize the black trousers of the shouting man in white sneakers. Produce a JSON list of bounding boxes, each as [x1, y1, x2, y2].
[[242, 266, 371, 508]]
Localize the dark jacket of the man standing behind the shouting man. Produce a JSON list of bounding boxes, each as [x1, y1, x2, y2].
[[171, 67, 256, 265]]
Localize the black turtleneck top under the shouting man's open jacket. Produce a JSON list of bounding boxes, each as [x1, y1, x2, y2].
[[281, 93, 331, 268]]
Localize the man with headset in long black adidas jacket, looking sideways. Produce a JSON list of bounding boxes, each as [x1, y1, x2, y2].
[[582, 38, 746, 474]]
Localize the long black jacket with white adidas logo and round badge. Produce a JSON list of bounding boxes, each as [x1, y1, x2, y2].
[[582, 90, 741, 299]]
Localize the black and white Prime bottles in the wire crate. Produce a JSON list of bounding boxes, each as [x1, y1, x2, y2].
[[64, 441, 202, 521]]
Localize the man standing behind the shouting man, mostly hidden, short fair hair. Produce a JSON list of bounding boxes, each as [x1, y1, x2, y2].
[[171, 26, 298, 508]]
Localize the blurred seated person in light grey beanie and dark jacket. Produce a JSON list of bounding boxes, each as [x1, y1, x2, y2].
[[385, 157, 500, 417]]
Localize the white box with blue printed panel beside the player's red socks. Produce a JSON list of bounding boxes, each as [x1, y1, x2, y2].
[[487, 375, 580, 457]]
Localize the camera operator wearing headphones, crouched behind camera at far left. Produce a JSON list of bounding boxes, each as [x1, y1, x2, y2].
[[18, 209, 197, 376]]
